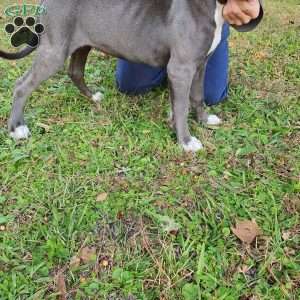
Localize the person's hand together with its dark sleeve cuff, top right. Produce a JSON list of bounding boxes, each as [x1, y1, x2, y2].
[[223, 0, 264, 32]]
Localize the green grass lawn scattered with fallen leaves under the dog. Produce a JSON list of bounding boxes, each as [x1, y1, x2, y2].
[[0, 0, 300, 300]]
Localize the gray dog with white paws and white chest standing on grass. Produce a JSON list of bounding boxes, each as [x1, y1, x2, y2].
[[0, 0, 226, 152]]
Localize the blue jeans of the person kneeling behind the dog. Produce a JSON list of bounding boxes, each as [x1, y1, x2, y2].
[[116, 24, 229, 105]]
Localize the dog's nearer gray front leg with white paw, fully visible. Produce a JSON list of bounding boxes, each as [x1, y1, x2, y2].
[[168, 59, 203, 152]]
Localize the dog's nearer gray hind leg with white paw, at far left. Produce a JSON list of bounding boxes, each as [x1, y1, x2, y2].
[[8, 47, 66, 140]]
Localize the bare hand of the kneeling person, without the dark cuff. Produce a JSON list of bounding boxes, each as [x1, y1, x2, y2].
[[223, 0, 260, 26]]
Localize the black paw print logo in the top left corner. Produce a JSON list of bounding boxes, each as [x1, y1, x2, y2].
[[5, 17, 45, 48]]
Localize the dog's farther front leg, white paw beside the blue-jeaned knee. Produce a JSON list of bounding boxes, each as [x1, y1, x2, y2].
[[190, 64, 222, 126]]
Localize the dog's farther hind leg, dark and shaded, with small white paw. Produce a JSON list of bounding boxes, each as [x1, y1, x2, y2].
[[69, 46, 103, 103]]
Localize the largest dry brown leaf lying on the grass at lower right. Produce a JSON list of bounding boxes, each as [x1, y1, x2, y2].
[[231, 220, 261, 244]]
